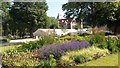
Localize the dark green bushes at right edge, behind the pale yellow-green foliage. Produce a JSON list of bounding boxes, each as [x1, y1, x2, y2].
[[89, 33, 120, 53]]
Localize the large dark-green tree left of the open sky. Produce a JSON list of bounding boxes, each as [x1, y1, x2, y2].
[[9, 2, 48, 37]]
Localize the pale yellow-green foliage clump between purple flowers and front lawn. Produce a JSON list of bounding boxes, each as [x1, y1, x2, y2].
[[60, 46, 109, 66]]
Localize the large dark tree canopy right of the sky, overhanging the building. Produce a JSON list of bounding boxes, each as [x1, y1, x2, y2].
[[62, 2, 120, 31]]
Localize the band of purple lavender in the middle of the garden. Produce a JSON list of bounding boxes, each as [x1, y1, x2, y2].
[[40, 41, 89, 59]]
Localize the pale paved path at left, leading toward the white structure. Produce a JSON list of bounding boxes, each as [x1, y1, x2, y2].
[[0, 38, 37, 46]]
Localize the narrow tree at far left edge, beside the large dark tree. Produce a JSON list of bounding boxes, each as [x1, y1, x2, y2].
[[0, 1, 11, 35]]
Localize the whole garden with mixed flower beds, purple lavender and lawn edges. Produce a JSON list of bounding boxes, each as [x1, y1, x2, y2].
[[0, 33, 120, 68]]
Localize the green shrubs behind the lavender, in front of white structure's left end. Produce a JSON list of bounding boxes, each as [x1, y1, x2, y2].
[[17, 35, 67, 52]]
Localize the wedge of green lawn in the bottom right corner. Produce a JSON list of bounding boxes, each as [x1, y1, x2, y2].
[[77, 54, 118, 66]]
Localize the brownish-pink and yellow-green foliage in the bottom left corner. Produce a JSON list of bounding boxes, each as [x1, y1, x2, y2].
[[2, 49, 39, 67]]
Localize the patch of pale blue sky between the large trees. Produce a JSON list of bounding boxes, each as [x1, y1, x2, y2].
[[47, 0, 68, 18]]
